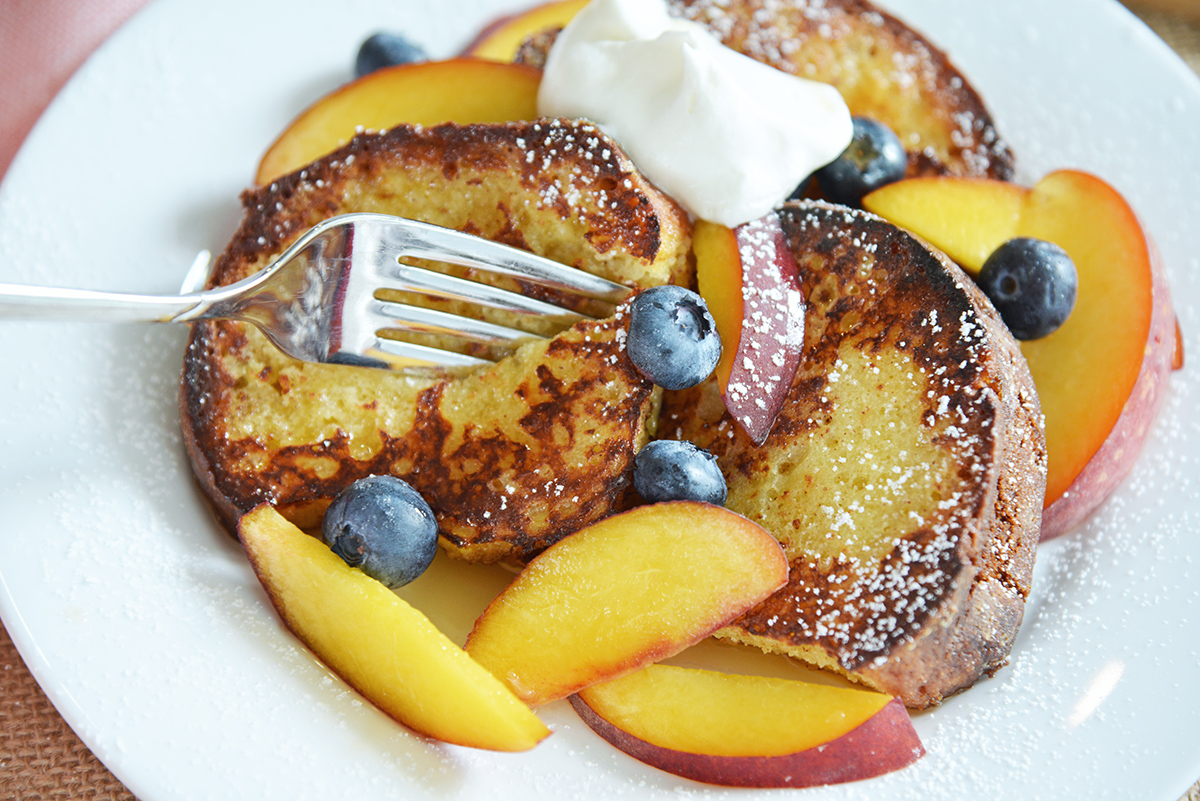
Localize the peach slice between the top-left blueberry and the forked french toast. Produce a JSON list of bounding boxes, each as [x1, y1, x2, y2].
[[254, 58, 541, 186]]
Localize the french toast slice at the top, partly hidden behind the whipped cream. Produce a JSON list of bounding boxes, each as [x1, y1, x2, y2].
[[517, 0, 1013, 180]]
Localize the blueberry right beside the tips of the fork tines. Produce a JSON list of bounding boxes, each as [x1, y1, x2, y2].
[[626, 284, 721, 390]]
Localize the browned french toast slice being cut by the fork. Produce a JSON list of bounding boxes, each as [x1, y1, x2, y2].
[[180, 120, 692, 561]]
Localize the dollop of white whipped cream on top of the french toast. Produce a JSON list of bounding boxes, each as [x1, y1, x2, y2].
[[538, 0, 851, 227]]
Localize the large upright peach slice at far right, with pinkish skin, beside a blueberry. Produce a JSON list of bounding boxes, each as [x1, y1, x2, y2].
[[1019, 171, 1182, 540]]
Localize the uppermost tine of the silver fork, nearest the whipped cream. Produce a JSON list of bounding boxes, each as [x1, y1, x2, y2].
[[369, 215, 631, 303]]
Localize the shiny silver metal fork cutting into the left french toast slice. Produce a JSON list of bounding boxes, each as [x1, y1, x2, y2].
[[0, 213, 630, 369]]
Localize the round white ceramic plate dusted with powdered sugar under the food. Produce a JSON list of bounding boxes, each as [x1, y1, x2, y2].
[[0, 0, 1200, 801]]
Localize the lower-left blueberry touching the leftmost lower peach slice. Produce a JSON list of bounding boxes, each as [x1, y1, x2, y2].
[[320, 476, 438, 589]]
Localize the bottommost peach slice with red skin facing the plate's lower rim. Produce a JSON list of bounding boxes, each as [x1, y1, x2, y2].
[[571, 664, 925, 787]]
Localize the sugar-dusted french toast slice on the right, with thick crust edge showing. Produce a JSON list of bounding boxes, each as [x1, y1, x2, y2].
[[659, 200, 1046, 707]]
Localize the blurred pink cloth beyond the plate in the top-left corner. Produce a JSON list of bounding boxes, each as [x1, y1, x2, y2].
[[0, 0, 148, 177]]
